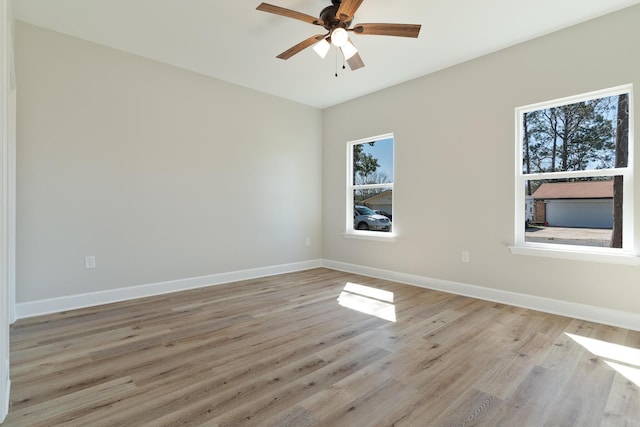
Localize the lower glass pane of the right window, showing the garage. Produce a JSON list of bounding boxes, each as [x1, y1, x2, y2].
[[524, 176, 623, 248]]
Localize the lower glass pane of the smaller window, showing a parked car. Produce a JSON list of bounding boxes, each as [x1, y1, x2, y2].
[[353, 188, 393, 232]]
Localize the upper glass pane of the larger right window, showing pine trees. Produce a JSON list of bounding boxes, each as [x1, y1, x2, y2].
[[522, 94, 629, 174]]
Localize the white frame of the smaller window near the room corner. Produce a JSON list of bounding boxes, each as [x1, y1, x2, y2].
[[343, 133, 397, 242]]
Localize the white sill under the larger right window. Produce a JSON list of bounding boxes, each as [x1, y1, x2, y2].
[[509, 245, 640, 266]]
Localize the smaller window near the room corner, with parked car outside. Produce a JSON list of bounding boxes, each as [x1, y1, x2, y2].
[[345, 134, 393, 239]]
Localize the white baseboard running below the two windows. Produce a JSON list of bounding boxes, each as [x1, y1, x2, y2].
[[322, 260, 640, 331]]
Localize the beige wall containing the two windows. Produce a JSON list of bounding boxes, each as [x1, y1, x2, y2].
[[323, 6, 640, 313]]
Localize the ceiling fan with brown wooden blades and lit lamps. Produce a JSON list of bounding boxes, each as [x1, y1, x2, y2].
[[256, 0, 421, 70]]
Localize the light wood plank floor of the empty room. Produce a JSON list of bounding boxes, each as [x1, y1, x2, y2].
[[5, 269, 640, 427]]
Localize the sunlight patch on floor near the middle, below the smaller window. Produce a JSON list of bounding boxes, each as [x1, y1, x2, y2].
[[338, 282, 396, 322]]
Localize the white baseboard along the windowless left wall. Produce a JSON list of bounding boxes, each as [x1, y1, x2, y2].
[[15, 260, 322, 319]]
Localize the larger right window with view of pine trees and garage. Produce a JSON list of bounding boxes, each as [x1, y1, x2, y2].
[[512, 85, 635, 259]]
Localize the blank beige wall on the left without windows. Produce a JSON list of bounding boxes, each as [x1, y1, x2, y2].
[[16, 23, 322, 303]]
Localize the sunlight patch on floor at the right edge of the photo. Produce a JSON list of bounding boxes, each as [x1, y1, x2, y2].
[[566, 334, 640, 387]]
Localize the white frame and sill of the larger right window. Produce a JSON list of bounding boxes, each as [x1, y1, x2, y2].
[[509, 84, 640, 265]]
